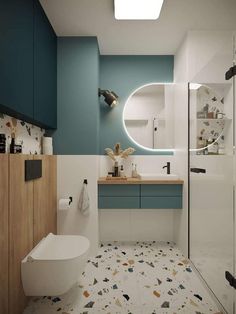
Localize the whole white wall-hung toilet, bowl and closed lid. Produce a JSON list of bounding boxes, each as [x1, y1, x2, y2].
[[21, 233, 90, 296]]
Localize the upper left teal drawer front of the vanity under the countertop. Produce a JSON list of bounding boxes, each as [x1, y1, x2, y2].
[[98, 184, 140, 197]]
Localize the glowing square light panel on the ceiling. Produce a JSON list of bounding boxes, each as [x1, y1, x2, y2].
[[114, 0, 164, 20]]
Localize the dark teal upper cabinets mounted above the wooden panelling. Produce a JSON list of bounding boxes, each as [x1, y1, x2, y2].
[[0, 0, 57, 129]]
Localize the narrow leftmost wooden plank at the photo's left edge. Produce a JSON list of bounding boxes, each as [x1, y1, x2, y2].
[[0, 154, 9, 313]]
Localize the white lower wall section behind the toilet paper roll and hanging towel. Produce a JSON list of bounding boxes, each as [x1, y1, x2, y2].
[[57, 155, 99, 255]]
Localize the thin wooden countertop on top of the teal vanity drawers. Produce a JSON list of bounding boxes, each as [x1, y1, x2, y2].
[[98, 177, 184, 184]]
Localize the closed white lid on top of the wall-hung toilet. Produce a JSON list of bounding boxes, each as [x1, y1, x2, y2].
[[28, 233, 90, 260]]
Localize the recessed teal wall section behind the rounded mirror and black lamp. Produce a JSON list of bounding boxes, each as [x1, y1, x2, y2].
[[99, 55, 174, 155]]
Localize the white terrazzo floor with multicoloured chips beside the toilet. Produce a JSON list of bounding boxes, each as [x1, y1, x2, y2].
[[24, 241, 221, 314]]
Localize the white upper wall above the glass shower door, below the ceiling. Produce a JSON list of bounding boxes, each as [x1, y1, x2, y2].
[[174, 31, 232, 83]]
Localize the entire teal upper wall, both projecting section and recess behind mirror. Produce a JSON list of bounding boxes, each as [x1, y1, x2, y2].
[[53, 37, 174, 155]]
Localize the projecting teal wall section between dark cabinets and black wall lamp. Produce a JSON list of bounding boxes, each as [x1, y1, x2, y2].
[[53, 37, 100, 155]]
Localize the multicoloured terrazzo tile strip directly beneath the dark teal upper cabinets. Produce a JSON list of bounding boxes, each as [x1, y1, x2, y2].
[[0, 113, 45, 154]]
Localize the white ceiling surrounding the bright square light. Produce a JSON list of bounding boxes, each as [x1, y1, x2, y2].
[[40, 0, 236, 55]]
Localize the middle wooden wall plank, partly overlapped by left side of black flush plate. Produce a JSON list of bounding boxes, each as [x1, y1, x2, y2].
[[9, 155, 33, 314]]
